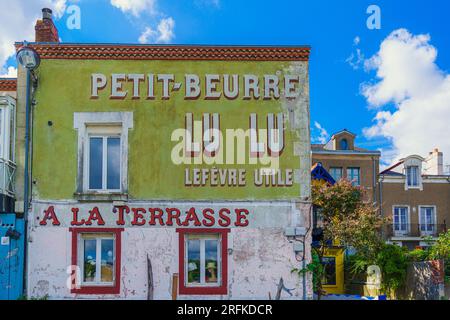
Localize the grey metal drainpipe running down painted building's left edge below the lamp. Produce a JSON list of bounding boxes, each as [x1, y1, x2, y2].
[[23, 69, 31, 294]]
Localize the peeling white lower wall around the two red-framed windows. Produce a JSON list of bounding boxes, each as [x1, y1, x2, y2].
[[27, 202, 312, 300]]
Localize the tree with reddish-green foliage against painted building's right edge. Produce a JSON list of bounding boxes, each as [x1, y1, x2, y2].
[[294, 180, 385, 299]]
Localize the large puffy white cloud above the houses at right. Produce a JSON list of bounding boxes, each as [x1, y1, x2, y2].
[[362, 29, 450, 165]]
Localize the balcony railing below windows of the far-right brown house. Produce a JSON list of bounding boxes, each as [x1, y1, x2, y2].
[[385, 223, 447, 238]]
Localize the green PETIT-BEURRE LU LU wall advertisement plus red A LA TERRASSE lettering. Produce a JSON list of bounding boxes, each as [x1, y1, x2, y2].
[[34, 60, 309, 227]]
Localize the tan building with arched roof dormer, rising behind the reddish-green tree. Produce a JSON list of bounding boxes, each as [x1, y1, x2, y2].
[[311, 129, 381, 202]]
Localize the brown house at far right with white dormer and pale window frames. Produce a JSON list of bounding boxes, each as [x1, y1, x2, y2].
[[379, 149, 450, 249]]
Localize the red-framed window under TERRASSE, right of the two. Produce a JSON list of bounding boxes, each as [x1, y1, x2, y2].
[[179, 229, 228, 294]]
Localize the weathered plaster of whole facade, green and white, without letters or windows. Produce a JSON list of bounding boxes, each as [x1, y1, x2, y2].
[[23, 55, 312, 299]]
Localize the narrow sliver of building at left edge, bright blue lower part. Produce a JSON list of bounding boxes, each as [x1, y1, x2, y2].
[[0, 78, 24, 300]]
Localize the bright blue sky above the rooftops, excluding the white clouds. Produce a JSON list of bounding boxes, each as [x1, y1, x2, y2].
[[2, 0, 450, 168]]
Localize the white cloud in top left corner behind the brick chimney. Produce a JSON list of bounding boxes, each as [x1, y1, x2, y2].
[[0, 0, 67, 73]]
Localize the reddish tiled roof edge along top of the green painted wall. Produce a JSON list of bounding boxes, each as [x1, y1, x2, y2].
[[15, 42, 311, 61]]
